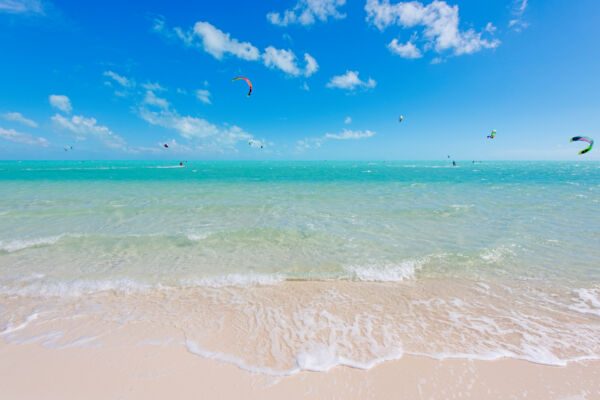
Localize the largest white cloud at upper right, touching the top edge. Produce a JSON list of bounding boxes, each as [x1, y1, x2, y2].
[[365, 0, 500, 55]]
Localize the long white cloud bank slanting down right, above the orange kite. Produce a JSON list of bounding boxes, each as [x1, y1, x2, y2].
[[153, 18, 319, 77]]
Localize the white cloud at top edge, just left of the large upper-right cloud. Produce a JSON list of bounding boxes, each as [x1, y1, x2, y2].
[[267, 0, 346, 26]]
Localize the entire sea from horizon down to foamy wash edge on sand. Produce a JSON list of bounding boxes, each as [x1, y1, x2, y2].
[[0, 161, 600, 375]]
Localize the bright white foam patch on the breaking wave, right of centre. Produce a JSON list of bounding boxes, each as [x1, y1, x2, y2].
[[344, 260, 423, 282]]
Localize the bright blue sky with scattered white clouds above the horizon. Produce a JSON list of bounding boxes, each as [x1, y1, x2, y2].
[[0, 0, 600, 161]]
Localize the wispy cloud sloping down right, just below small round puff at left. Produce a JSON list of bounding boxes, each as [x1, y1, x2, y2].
[[52, 114, 127, 150]]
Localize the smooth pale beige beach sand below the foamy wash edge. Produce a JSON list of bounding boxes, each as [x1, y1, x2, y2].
[[0, 342, 600, 400]]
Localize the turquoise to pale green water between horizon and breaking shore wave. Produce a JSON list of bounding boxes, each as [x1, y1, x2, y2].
[[0, 162, 600, 284]]
